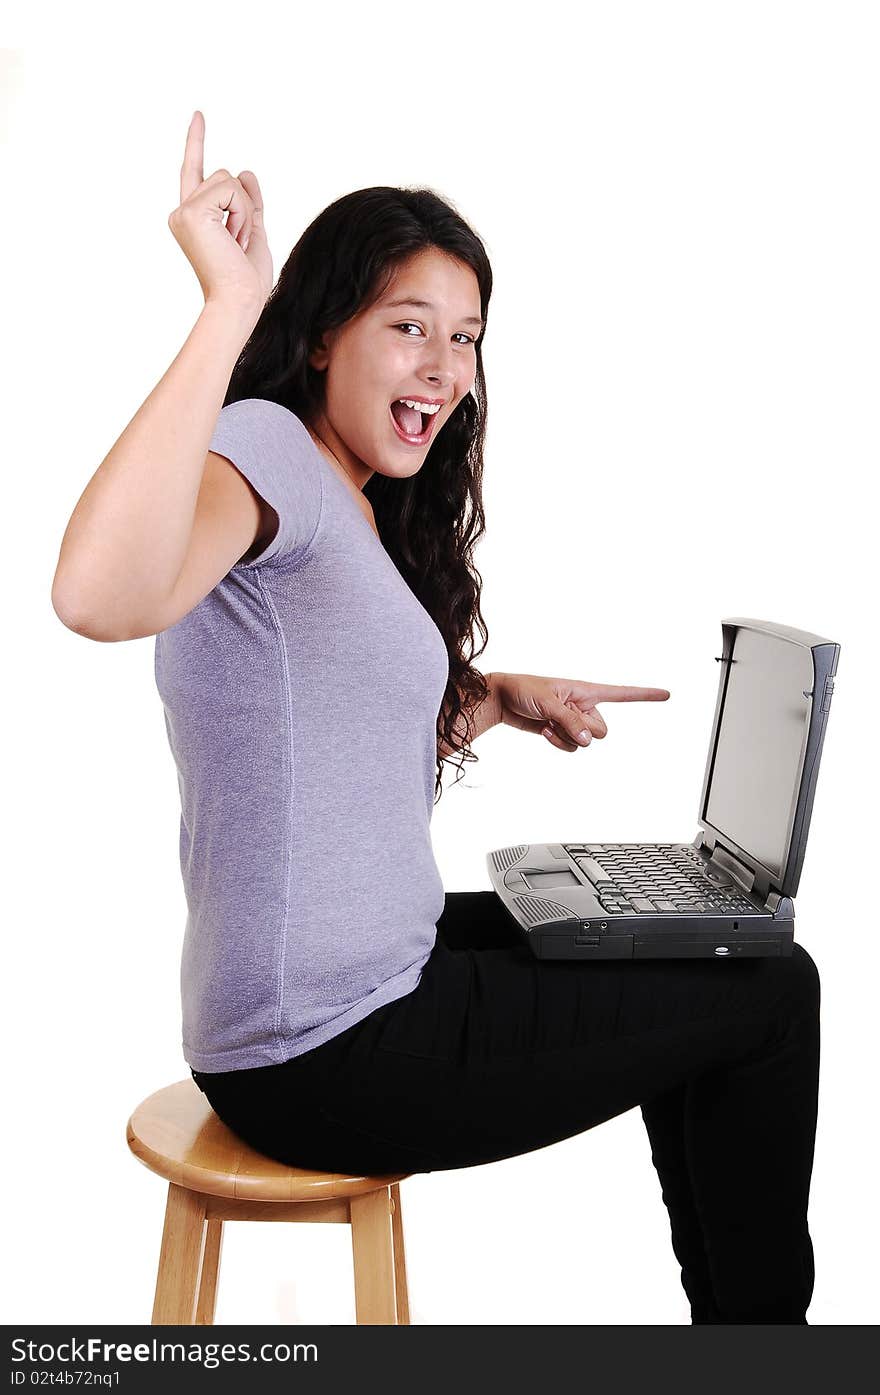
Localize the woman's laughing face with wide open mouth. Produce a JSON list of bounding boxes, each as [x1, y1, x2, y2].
[[310, 248, 483, 488]]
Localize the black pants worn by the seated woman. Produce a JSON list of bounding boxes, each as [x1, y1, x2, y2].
[[192, 891, 820, 1324]]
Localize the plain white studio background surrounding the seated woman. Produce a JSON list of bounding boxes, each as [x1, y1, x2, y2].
[[3, 0, 880, 1324]]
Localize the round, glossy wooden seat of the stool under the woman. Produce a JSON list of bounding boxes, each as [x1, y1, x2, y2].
[[126, 1078, 409, 1201]]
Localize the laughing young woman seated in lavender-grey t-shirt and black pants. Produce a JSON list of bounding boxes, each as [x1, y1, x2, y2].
[[53, 112, 820, 1324]]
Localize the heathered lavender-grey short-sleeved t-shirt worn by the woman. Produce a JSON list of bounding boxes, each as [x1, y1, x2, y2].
[[155, 398, 449, 1071]]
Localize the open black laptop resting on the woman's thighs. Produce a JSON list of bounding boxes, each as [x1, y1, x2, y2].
[[487, 618, 840, 960]]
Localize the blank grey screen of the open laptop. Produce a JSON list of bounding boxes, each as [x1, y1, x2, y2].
[[701, 629, 813, 877]]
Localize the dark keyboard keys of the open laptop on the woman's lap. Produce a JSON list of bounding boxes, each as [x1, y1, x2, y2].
[[562, 843, 763, 915]]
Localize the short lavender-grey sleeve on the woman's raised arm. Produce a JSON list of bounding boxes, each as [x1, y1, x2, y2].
[[209, 398, 324, 568]]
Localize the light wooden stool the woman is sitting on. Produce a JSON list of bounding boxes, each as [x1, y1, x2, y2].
[[126, 1078, 410, 1325]]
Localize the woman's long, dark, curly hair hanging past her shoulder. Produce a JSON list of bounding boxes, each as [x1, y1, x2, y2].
[[223, 186, 492, 804]]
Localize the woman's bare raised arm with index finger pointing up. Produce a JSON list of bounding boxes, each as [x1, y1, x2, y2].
[[52, 112, 272, 639]]
